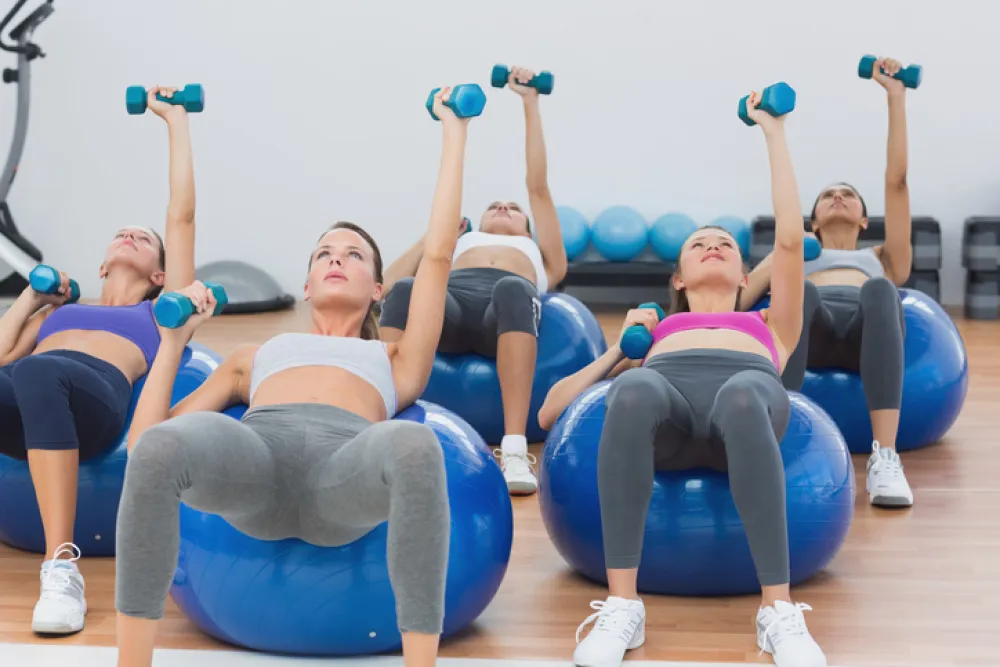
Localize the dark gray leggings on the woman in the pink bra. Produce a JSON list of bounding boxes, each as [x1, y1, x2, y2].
[[597, 350, 791, 586]]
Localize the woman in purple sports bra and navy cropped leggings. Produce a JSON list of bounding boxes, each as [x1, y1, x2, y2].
[[0, 88, 195, 634]]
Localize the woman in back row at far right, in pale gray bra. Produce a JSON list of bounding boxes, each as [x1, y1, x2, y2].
[[743, 58, 913, 507]]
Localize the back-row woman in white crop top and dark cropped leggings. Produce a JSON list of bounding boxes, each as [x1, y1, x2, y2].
[[379, 67, 566, 494]]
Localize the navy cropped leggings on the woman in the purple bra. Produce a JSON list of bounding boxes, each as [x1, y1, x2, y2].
[[0, 350, 132, 461]]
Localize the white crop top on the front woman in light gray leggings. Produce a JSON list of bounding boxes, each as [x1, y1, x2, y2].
[[250, 333, 397, 419]]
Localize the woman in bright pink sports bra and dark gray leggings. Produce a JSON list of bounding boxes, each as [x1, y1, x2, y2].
[[539, 93, 826, 667]]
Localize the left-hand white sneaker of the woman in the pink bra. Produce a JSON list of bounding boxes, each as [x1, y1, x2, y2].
[[573, 596, 646, 667]]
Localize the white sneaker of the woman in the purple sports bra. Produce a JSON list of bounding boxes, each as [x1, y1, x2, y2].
[[31, 542, 87, 635]]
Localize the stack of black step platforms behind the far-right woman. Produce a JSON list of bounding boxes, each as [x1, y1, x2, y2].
[[750, 215, 941, 303]]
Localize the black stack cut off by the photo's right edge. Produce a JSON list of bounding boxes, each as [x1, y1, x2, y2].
[[962, 217, 1000, 320]]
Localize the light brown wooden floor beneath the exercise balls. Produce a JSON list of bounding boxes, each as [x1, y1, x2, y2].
[[0, 308, 1000, 667]]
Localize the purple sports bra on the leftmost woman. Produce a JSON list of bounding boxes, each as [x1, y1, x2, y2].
[[38, 301, 160, 366]]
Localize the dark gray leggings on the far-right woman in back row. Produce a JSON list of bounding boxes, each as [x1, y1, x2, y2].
[[781, 277, 906, 411]]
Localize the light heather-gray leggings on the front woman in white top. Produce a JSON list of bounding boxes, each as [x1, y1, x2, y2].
[[115, 403, 450, 634]]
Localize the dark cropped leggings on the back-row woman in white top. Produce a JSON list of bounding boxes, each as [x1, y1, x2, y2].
[[379, 268, 542, 358]]
